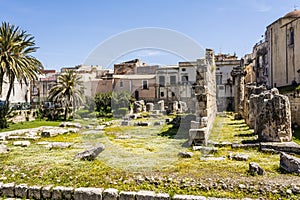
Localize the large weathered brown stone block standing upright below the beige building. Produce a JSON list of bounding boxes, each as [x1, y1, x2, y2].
[[250, 88, 292, 142]]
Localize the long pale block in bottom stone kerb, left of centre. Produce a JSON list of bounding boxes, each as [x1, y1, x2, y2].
[[74, 187, 103, 200]]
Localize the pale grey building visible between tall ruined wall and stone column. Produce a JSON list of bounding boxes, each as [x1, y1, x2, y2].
[[215, 53, 241, 112]]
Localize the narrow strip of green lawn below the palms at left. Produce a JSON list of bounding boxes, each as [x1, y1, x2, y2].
[[0, 120, 61, 132]]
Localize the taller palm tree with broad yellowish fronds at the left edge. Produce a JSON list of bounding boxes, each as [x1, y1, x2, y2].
[[0, 22, 43, 106]]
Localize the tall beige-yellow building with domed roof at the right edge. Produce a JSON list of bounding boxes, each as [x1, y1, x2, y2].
[[264, 10, 300, 87]]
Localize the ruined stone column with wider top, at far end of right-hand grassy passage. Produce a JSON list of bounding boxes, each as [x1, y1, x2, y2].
[[231, 66, 246, 119]]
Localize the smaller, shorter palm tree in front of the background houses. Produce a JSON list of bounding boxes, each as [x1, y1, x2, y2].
[[49, 70, 83, 120]]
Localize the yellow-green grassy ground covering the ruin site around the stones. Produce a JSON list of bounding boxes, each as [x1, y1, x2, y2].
[[0, 115, 300, 199]]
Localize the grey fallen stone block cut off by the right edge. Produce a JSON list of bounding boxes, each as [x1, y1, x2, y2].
[[280, 153, 300, 174]]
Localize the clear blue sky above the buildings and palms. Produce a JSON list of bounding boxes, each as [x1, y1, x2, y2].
[[0, 0, 300, 70]]
